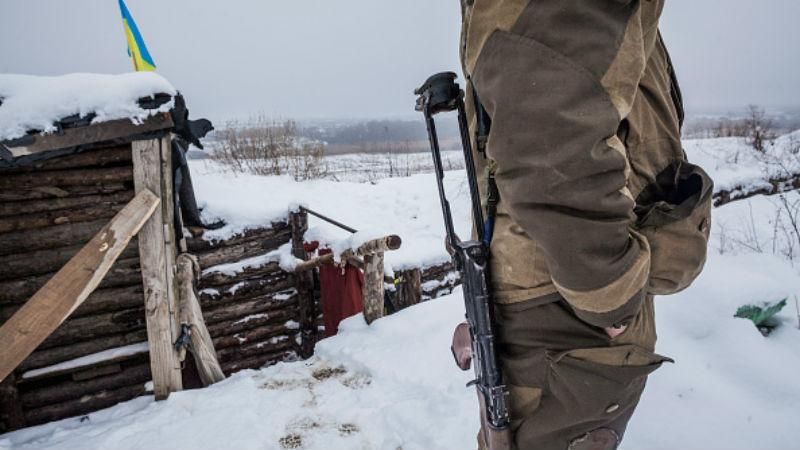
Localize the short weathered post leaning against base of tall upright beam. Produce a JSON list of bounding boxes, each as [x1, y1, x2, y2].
[[177, 253, 225, 386]]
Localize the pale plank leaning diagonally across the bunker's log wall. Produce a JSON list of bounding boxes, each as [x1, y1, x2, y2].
[[0, 190, 160, 379]]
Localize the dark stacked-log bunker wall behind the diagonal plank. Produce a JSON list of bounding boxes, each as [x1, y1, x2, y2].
[[0, 145, 150, 429]]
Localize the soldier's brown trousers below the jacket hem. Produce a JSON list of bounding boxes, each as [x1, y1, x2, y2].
[[478, 295, 670, 450]]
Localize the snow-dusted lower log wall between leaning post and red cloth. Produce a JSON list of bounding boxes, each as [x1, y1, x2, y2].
[[187, 222, 308, 374]]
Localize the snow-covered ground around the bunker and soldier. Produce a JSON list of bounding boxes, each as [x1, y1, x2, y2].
[[0, 135, 800, 450]]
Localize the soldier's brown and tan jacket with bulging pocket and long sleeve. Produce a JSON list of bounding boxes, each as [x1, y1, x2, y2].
[[461, 0, 712, 327]]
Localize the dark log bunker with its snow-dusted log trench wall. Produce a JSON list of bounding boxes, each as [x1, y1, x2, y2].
[[0, 78, 459, 433]]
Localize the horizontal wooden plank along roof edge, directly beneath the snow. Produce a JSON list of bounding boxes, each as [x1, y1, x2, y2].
[[3, 113, 174, 158]]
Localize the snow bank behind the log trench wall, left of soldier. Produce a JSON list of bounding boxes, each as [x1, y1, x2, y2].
[[189, 160, 470, 270]]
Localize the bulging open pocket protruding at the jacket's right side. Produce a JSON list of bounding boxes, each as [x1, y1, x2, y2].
[[635, 161, 714, 295]]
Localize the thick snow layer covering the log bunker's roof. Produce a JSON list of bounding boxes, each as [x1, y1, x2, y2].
[[0, 72, 177, 141]]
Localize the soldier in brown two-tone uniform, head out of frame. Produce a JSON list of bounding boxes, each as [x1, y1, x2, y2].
[[461, 0, 712, 450]]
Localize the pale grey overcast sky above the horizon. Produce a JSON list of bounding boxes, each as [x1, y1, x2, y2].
[[0, 0, 800, 121]]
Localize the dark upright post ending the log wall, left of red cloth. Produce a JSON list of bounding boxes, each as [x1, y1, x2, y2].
[[289, 211, 317, 358]]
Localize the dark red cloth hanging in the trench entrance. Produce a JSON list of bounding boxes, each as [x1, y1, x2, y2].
[[306, 243, 364, 336]]
